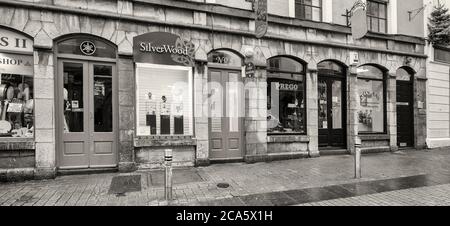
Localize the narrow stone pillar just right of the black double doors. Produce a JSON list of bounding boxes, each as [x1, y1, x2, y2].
[[347, 66, 359, 154]]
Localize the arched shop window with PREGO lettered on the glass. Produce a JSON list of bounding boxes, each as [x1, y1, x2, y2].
[[267, 57, 306, 134]]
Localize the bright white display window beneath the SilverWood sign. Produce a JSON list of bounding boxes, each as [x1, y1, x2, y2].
[[136, 63, 193, 136]]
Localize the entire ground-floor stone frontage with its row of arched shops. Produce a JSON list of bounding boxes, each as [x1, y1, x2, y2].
[[0, 0, 427, 178]]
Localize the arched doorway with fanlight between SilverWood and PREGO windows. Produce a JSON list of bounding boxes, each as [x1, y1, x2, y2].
[[208, 50, 244, 162]]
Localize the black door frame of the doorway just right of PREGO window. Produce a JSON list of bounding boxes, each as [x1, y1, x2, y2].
[[317, 67, 349, 149]]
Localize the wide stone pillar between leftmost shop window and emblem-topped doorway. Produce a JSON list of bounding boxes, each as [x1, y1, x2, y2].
[[34, 48, 56, 179]]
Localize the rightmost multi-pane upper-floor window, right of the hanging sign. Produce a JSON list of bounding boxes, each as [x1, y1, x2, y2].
[[367, 0, 387, 33]]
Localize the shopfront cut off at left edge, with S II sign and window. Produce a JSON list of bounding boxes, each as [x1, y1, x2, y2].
[[0, 27, 35, 169]]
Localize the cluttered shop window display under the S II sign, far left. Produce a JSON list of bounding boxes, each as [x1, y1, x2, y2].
[[0, 53, 34, 138]]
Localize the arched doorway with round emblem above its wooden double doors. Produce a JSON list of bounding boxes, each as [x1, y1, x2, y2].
[[56, 35, 118, 169]]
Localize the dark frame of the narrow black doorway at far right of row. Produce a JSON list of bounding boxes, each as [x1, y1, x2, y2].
[[395, 74, 416, 149]]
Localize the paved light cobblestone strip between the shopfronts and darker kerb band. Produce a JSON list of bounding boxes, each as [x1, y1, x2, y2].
[[0, 149, 450, 206]]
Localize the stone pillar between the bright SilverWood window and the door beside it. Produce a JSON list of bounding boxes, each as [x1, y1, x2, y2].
[[193, 62, 209, 166]]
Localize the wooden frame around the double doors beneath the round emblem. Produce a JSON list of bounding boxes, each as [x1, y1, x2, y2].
[[53, 56, 120, 170]]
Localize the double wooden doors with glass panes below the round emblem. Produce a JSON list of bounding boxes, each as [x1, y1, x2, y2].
[[57, 60, 117, 169]]
